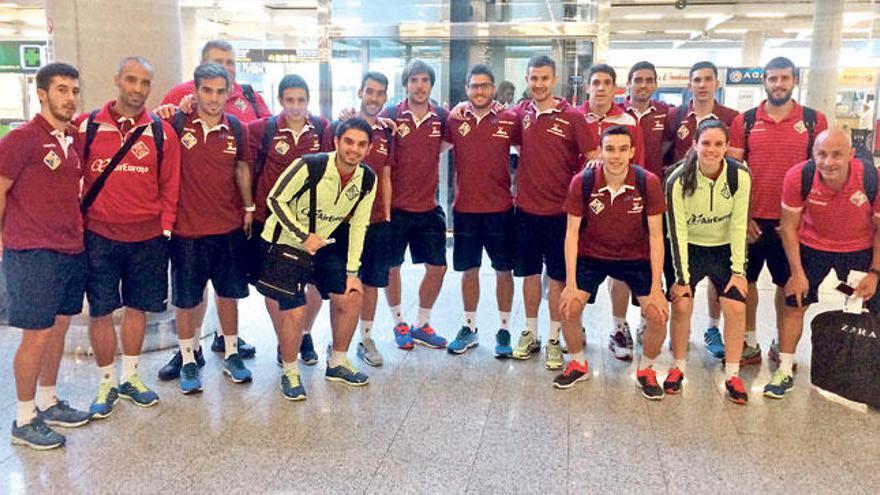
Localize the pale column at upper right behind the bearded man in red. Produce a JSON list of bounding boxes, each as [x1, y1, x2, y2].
[[806, 0, 846, 120]]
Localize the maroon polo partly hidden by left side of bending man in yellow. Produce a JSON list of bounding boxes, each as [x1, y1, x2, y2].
[[247, 113, 330, 222]]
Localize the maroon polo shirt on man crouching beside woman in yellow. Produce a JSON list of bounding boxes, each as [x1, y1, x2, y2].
[[565, 167, 666, 260]]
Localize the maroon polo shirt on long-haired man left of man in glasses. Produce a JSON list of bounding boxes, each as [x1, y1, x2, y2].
[[382, 100, 443, 213]]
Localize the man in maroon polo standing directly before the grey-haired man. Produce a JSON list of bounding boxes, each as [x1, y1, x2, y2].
[[160, 63, 254, 393]]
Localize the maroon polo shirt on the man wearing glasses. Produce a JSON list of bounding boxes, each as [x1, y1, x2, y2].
[[445, 107, 519, 213]]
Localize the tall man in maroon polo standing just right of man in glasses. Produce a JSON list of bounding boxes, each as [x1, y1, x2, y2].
[[512, 55, 598, 369]]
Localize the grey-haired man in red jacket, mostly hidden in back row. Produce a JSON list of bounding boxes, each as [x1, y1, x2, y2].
[[162, 40, 272, 123]]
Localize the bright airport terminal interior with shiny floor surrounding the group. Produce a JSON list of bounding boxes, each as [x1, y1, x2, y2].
[[0, 0, 880, 494]]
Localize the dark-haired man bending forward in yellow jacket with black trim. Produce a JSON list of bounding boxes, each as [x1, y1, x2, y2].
[[262, 118, 376, 400]]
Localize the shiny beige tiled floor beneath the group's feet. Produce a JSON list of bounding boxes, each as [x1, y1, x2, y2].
[[0, 258, 880, 494]]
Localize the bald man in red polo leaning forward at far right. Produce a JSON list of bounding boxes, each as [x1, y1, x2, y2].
[[764, 128, 880, 399]]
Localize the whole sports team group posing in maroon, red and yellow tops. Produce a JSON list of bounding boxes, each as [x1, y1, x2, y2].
[[0, 41, 880, 449]]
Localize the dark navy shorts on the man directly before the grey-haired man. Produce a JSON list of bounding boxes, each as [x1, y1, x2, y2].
[[170, 229, 248, 309]]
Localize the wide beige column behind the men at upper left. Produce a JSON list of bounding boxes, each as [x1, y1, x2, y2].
[[46, 0, 182, 110]]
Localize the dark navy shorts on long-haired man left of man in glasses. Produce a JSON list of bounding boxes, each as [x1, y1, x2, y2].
[[390, 206, 446, 267]]
